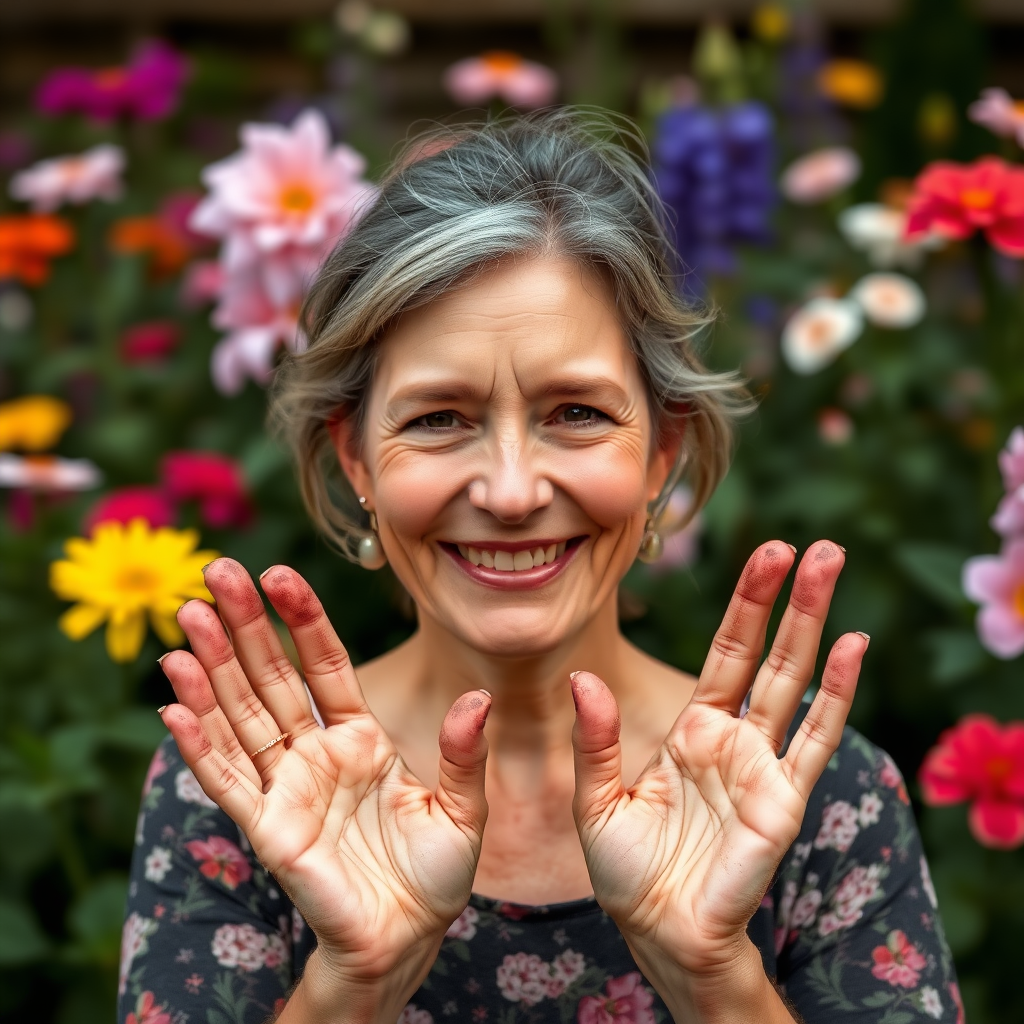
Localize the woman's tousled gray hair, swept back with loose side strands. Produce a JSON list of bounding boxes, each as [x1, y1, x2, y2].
[[270, 109, 750, 558]]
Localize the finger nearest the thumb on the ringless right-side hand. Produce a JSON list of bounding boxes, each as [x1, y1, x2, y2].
[[691, 541, 796, 714]]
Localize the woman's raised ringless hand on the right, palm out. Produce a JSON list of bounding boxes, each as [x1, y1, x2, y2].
[[572, 541, 867, 980]]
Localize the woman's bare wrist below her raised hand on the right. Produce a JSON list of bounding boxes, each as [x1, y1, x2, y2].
[[630, 935, 796, 1024]]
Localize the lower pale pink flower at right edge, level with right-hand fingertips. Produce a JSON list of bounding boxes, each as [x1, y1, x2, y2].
[[964, 537, 1024, 659]]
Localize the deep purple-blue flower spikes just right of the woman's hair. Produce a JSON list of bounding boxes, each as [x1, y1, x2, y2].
[[653, 102, 775, 288]]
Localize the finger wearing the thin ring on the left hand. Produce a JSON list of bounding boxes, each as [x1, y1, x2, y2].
[[178, 600, 287, 770]]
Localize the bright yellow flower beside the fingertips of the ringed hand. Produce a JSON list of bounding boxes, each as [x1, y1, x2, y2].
[[50, 518, 218, 662]]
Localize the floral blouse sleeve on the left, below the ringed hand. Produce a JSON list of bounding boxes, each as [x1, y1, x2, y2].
[[118, 737, 300, 1024]]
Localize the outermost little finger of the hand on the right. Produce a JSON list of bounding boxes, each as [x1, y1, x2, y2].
[[782, 633, 870, 800]]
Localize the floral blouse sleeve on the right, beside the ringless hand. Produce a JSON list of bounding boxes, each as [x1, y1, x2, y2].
[[770, 728, 964, 1024]]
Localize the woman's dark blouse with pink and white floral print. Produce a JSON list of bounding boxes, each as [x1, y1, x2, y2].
[[118, 706, 964, 1024]]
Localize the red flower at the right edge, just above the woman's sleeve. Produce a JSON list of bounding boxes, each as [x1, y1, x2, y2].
[[918, 715, 1024, 850]]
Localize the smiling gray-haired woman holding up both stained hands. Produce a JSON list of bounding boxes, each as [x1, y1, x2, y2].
[[121, 113, 958, 1024]]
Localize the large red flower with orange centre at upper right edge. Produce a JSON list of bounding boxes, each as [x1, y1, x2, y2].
[[906, 157, 1024, 256]]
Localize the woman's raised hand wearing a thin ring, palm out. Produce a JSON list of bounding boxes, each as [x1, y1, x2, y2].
[[162, 558, 490, 1019]]
